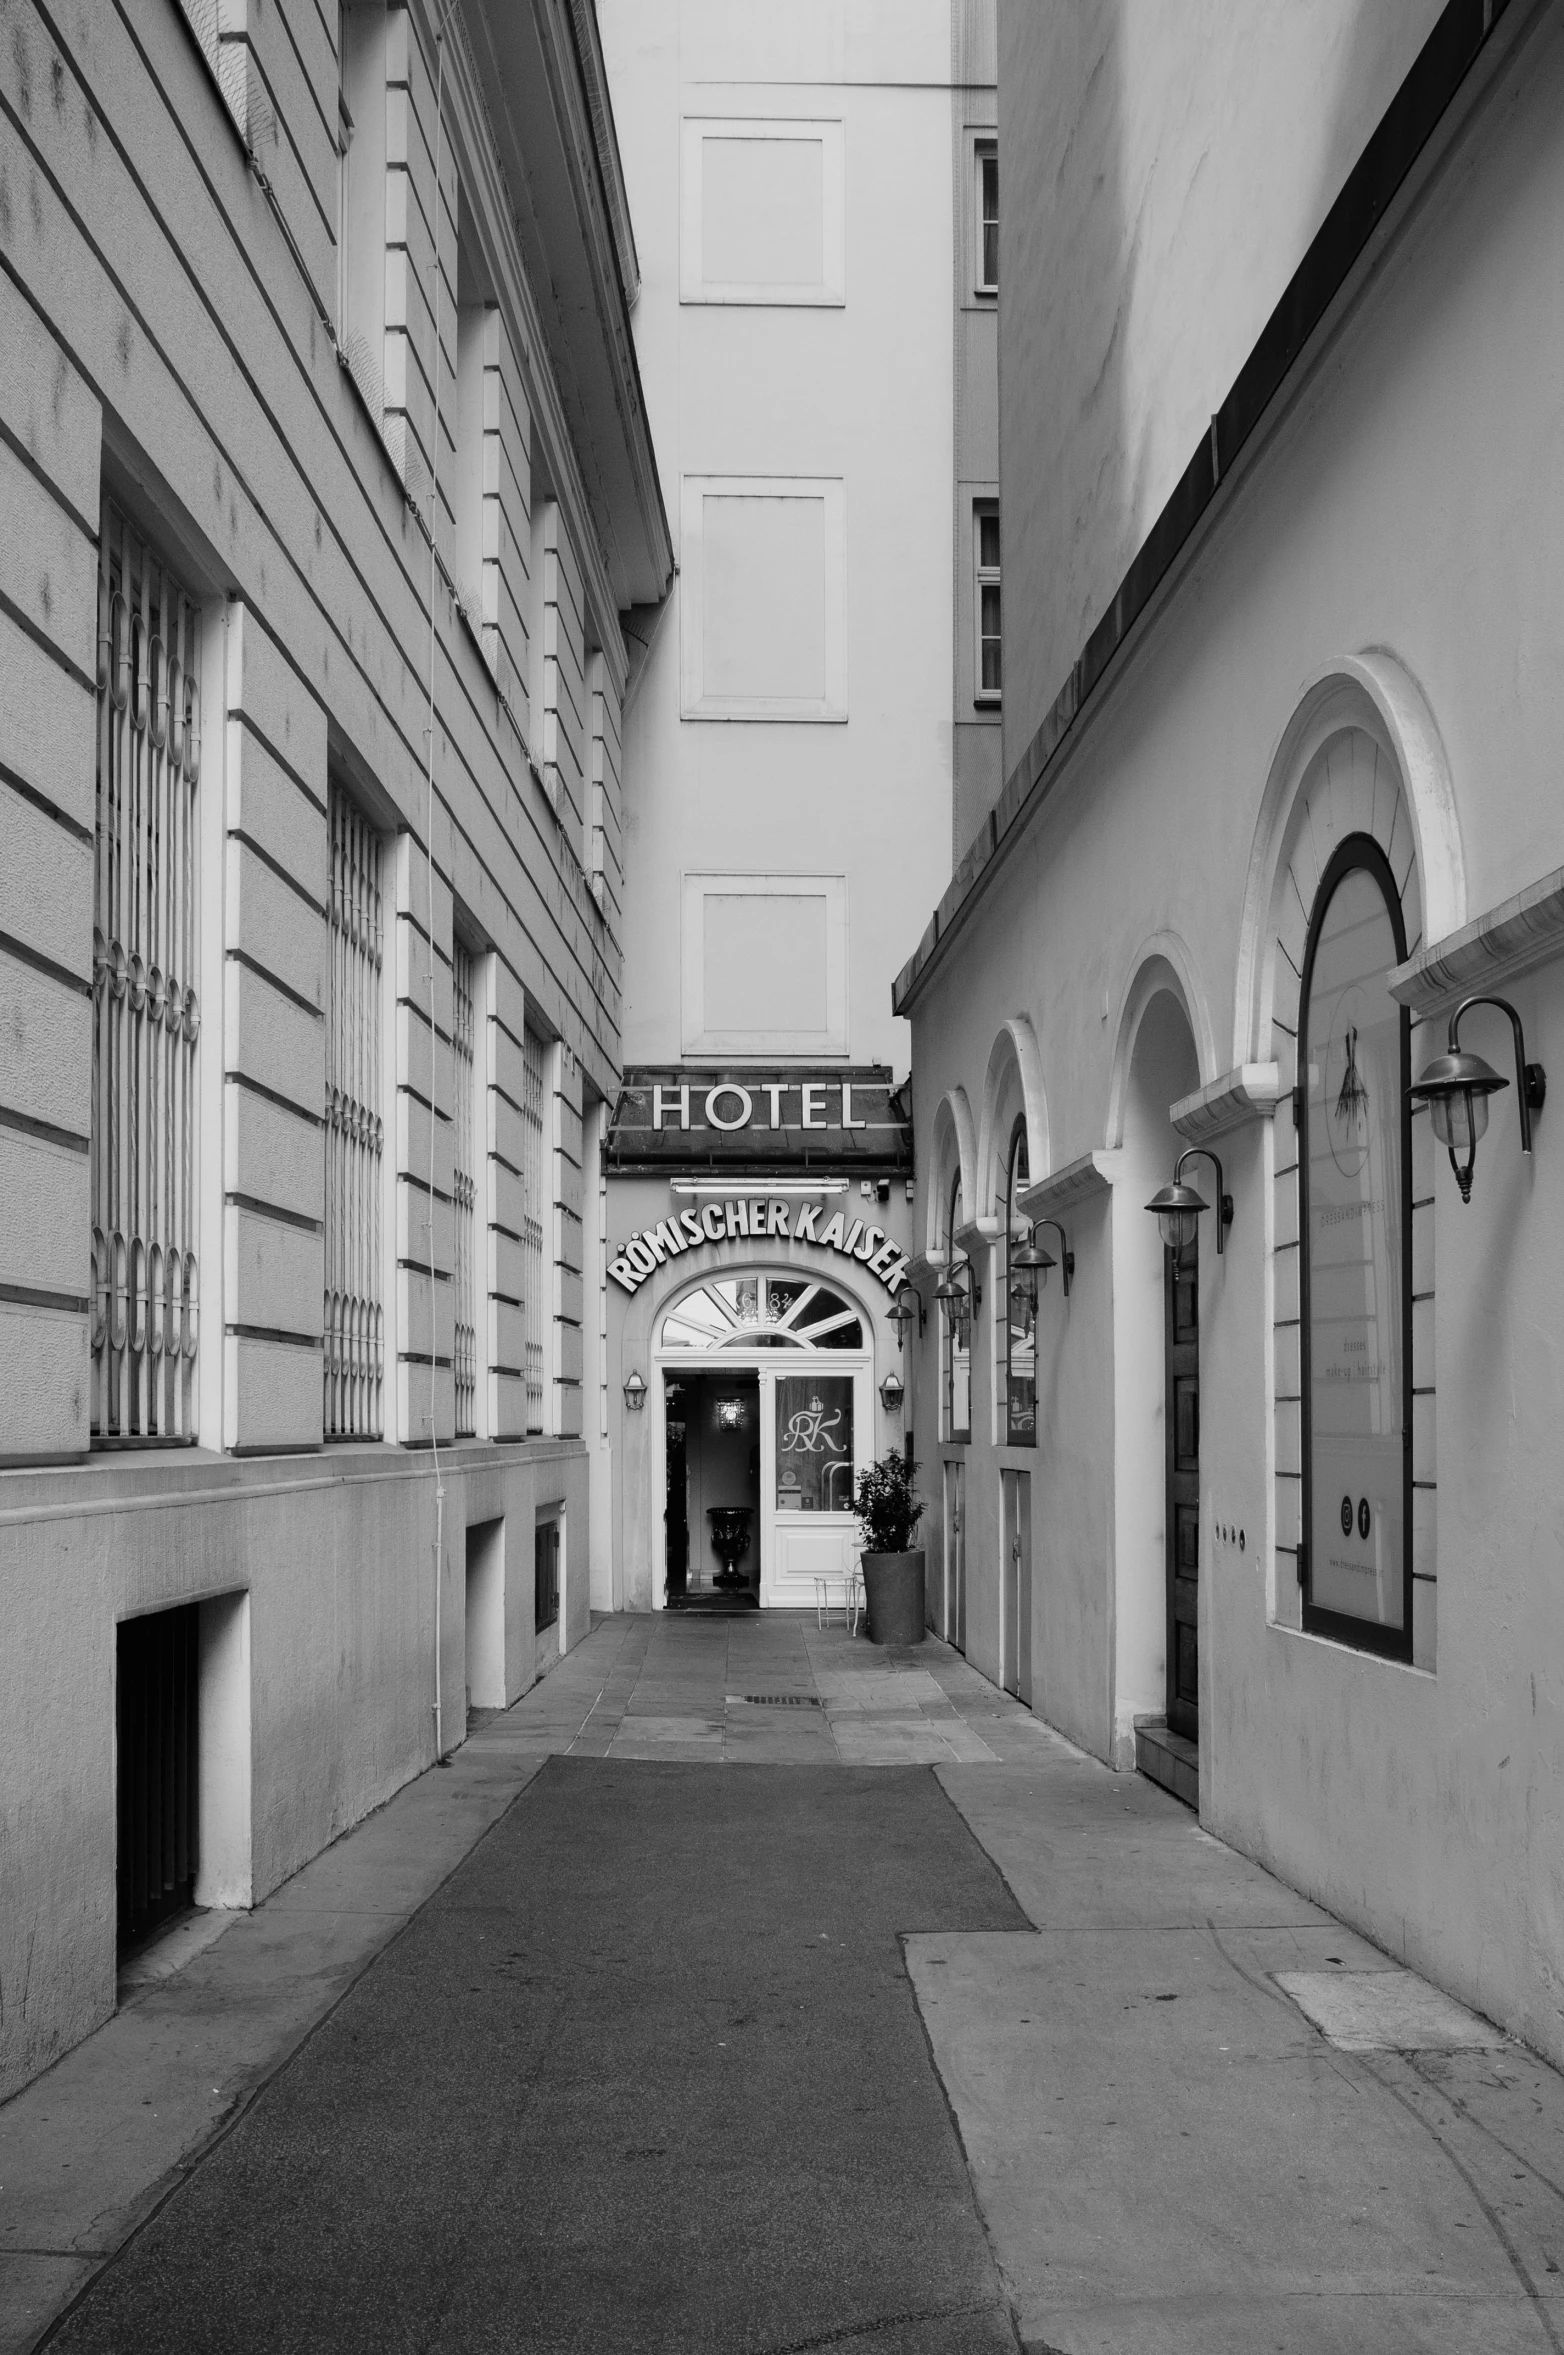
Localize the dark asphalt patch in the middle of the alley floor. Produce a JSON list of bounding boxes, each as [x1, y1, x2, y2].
[[52, 1757, 1029, 2355]]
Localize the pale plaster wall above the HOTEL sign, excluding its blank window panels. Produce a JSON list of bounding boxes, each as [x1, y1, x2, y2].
[[598, 0, 954, 1069]]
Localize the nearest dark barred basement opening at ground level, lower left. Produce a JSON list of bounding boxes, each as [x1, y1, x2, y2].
[[115, 1604, 200, 1950]]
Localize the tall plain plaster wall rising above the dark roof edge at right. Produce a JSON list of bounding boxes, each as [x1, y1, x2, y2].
[[999, 0, 1439, 775]]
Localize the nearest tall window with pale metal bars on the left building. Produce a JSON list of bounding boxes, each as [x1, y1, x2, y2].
[[92, 499, 200, 1441]]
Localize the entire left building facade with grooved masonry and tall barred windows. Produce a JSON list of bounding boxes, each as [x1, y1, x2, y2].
[[0, 0, 671, 2091]]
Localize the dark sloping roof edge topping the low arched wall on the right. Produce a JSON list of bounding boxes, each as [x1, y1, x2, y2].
[[890, 0, 1548, 1015]]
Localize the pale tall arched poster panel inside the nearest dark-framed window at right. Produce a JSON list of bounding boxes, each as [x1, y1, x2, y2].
[[1305, 869, 1406, 1627]]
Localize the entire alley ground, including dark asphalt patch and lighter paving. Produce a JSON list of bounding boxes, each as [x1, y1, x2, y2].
[[0, 1618, 1564, 2355]]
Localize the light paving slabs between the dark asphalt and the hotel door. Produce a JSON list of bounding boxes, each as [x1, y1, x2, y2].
[[471, 1611, 1058, 1766]]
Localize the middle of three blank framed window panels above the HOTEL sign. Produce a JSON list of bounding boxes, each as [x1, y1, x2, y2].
[[678, 473, 848, 721]]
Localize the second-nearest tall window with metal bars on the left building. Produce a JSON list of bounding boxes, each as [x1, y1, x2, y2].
[[325, 784, 386, 1439]]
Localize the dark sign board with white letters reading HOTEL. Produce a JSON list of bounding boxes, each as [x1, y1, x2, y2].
[[605, 1062, 912, 1182]]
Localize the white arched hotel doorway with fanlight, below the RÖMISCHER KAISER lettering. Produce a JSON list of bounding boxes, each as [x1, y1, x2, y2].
[[652, 1267, 874, 1611]]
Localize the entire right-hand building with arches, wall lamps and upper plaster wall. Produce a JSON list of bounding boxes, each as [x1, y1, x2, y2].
[[895, 0, 1564, 2058]]
